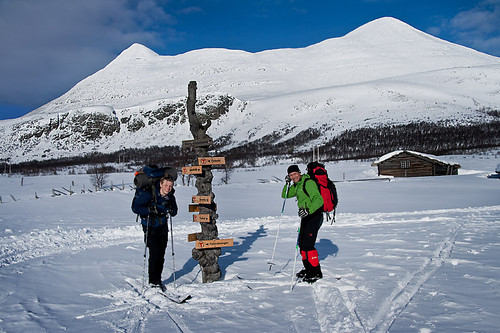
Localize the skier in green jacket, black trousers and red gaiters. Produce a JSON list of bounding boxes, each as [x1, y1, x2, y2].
[[281, 165, 323, 283]]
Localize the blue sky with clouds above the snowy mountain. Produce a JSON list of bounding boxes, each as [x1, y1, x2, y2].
[[0, 0, 500, 119]]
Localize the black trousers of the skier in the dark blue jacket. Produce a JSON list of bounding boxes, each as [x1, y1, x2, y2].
[[142, 224, 168, 284]]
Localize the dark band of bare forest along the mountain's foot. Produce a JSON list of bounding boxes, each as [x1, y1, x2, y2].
[[4, 121, 500, 175]]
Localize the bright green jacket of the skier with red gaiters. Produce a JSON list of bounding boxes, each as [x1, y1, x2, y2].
[[281, 174, 323, 214]]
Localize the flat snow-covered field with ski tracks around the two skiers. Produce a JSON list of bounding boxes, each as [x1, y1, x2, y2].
[[0, 152, 500, 332]]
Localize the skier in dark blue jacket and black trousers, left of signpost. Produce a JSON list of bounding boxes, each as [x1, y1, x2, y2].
[[132, 176, 177, 289]]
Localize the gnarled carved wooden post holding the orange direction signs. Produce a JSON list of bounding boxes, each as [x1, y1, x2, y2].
[[187, 81, 221, 283]]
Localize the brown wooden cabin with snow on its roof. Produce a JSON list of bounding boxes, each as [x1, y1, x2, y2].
[[372, 150, 460, 177]]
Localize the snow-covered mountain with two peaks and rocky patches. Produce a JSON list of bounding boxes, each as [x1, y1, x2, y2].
[[0, 18, 500, 162]]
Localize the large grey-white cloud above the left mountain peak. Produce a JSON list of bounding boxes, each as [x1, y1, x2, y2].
[[0, 0, 176, 106]]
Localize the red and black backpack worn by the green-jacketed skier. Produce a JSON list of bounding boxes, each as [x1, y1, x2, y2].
[[304, 162, 339, 219]]
